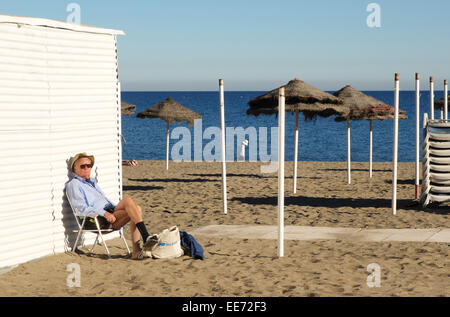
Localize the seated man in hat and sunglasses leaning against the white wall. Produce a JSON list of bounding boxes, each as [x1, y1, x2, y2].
[[66, 153, 157, 259]]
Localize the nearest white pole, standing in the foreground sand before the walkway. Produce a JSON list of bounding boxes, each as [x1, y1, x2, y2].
[[278, 87, 285, 258]]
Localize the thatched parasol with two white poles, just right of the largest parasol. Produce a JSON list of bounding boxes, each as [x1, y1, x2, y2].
[[333, 85, 408, 184]]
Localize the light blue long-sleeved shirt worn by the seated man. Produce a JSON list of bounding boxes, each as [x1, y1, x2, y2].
[[66, 173, 116, 216]]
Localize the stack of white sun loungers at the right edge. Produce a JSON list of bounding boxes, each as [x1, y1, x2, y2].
[[421, 120, 450, 207]]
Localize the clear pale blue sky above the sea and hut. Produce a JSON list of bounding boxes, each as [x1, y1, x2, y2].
[[0, 0, 450, 91]]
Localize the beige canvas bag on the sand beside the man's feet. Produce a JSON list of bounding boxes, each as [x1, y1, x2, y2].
[[147, 226, 184, 259]]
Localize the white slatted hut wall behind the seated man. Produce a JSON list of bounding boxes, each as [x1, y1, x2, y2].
[[0, 16, 122, 267]]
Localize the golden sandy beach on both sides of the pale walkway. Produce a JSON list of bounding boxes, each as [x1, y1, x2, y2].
[[0, 161, 450, 297]]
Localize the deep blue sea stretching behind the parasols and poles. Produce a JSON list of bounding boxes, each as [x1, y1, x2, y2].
[[122, 91, 444, 162]]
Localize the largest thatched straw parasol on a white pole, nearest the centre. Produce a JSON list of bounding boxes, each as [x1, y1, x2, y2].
[[247, 78, 345, 193]]
